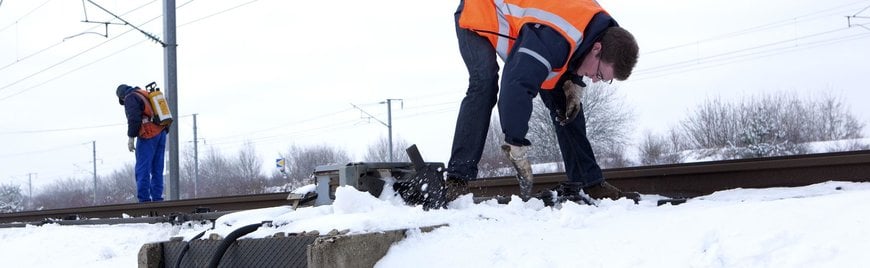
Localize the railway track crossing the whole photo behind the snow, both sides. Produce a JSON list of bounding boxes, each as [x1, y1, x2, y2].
[[0, 150, 870, 227]]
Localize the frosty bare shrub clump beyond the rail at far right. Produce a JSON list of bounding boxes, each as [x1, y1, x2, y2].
[[681, 94, 864, 159]]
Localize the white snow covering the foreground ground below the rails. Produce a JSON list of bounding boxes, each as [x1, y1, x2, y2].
[[0, 182, 870, 267]]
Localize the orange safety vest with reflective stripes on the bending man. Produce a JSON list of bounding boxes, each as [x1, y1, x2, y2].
[[459, 0, 606, 89]]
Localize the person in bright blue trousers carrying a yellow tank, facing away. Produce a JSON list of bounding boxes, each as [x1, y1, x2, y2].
[[115, 84, 169, 203]]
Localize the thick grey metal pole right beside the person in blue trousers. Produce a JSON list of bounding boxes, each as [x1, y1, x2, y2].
[[163, 0, 179, 200]]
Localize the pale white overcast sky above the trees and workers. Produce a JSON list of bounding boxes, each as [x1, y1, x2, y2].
[[0, 0, 870, 190]]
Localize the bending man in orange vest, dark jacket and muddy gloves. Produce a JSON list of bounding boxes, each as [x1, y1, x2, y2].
[[446, 0, 638, 202]]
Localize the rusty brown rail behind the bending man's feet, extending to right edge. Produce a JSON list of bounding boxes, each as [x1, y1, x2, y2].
[[469, 150, 870, 197]]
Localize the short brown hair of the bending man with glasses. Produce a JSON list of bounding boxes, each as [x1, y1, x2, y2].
[[598, 27, 639, 81]]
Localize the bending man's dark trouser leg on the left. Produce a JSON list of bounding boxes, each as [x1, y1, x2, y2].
[[447, 1, 499, 180]]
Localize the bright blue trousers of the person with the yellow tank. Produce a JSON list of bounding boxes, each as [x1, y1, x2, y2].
[[136, 131, 166, 203]]
